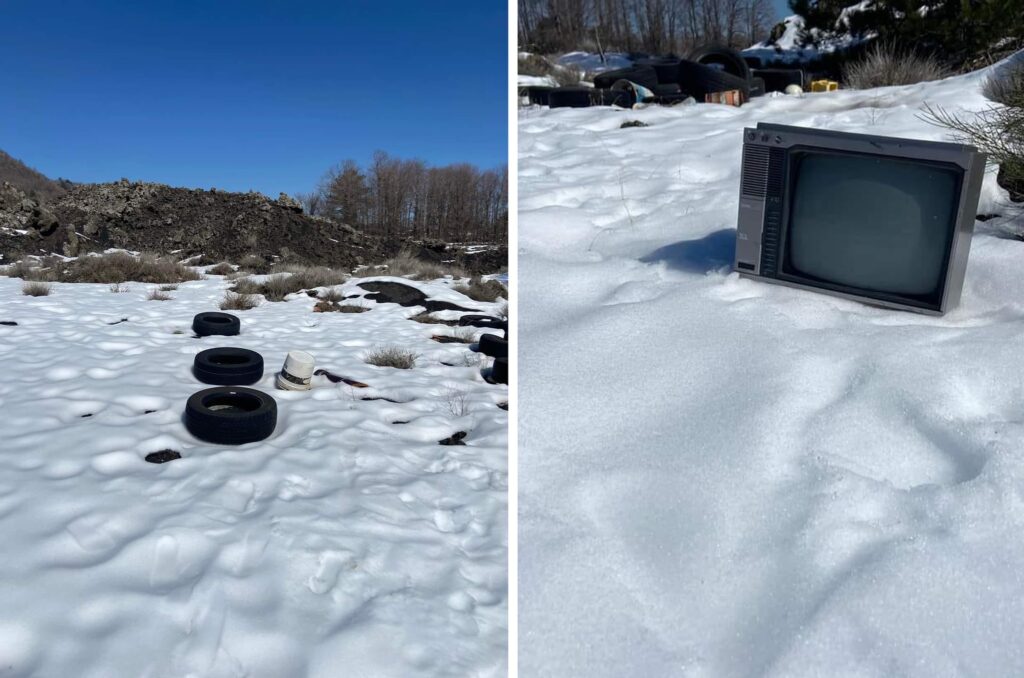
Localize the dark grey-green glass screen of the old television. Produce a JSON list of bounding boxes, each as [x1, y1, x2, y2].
[[782, 150, 963, 304]]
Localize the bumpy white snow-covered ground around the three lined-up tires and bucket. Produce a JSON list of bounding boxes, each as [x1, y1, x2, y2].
[[0, 277, 508, 678]]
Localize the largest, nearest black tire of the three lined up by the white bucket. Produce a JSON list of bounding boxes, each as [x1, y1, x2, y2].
[[184, 386, 278, 444]]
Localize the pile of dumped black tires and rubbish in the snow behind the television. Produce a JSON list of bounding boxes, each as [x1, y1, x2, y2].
[[520, 47, 805, 109]]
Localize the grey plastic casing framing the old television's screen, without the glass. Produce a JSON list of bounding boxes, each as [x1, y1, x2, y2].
[[733, 123, 985, 315]]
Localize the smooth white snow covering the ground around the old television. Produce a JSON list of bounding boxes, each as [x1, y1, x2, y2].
[[517, 54, 1024, 678]]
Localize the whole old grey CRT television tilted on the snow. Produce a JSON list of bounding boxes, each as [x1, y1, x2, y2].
[[735, 123, 985, 315]]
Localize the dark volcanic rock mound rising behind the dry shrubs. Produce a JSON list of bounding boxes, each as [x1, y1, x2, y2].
[[0, 179, 391, 268]]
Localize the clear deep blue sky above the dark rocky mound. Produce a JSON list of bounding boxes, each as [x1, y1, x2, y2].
[[0, 0, 508, 196]]
